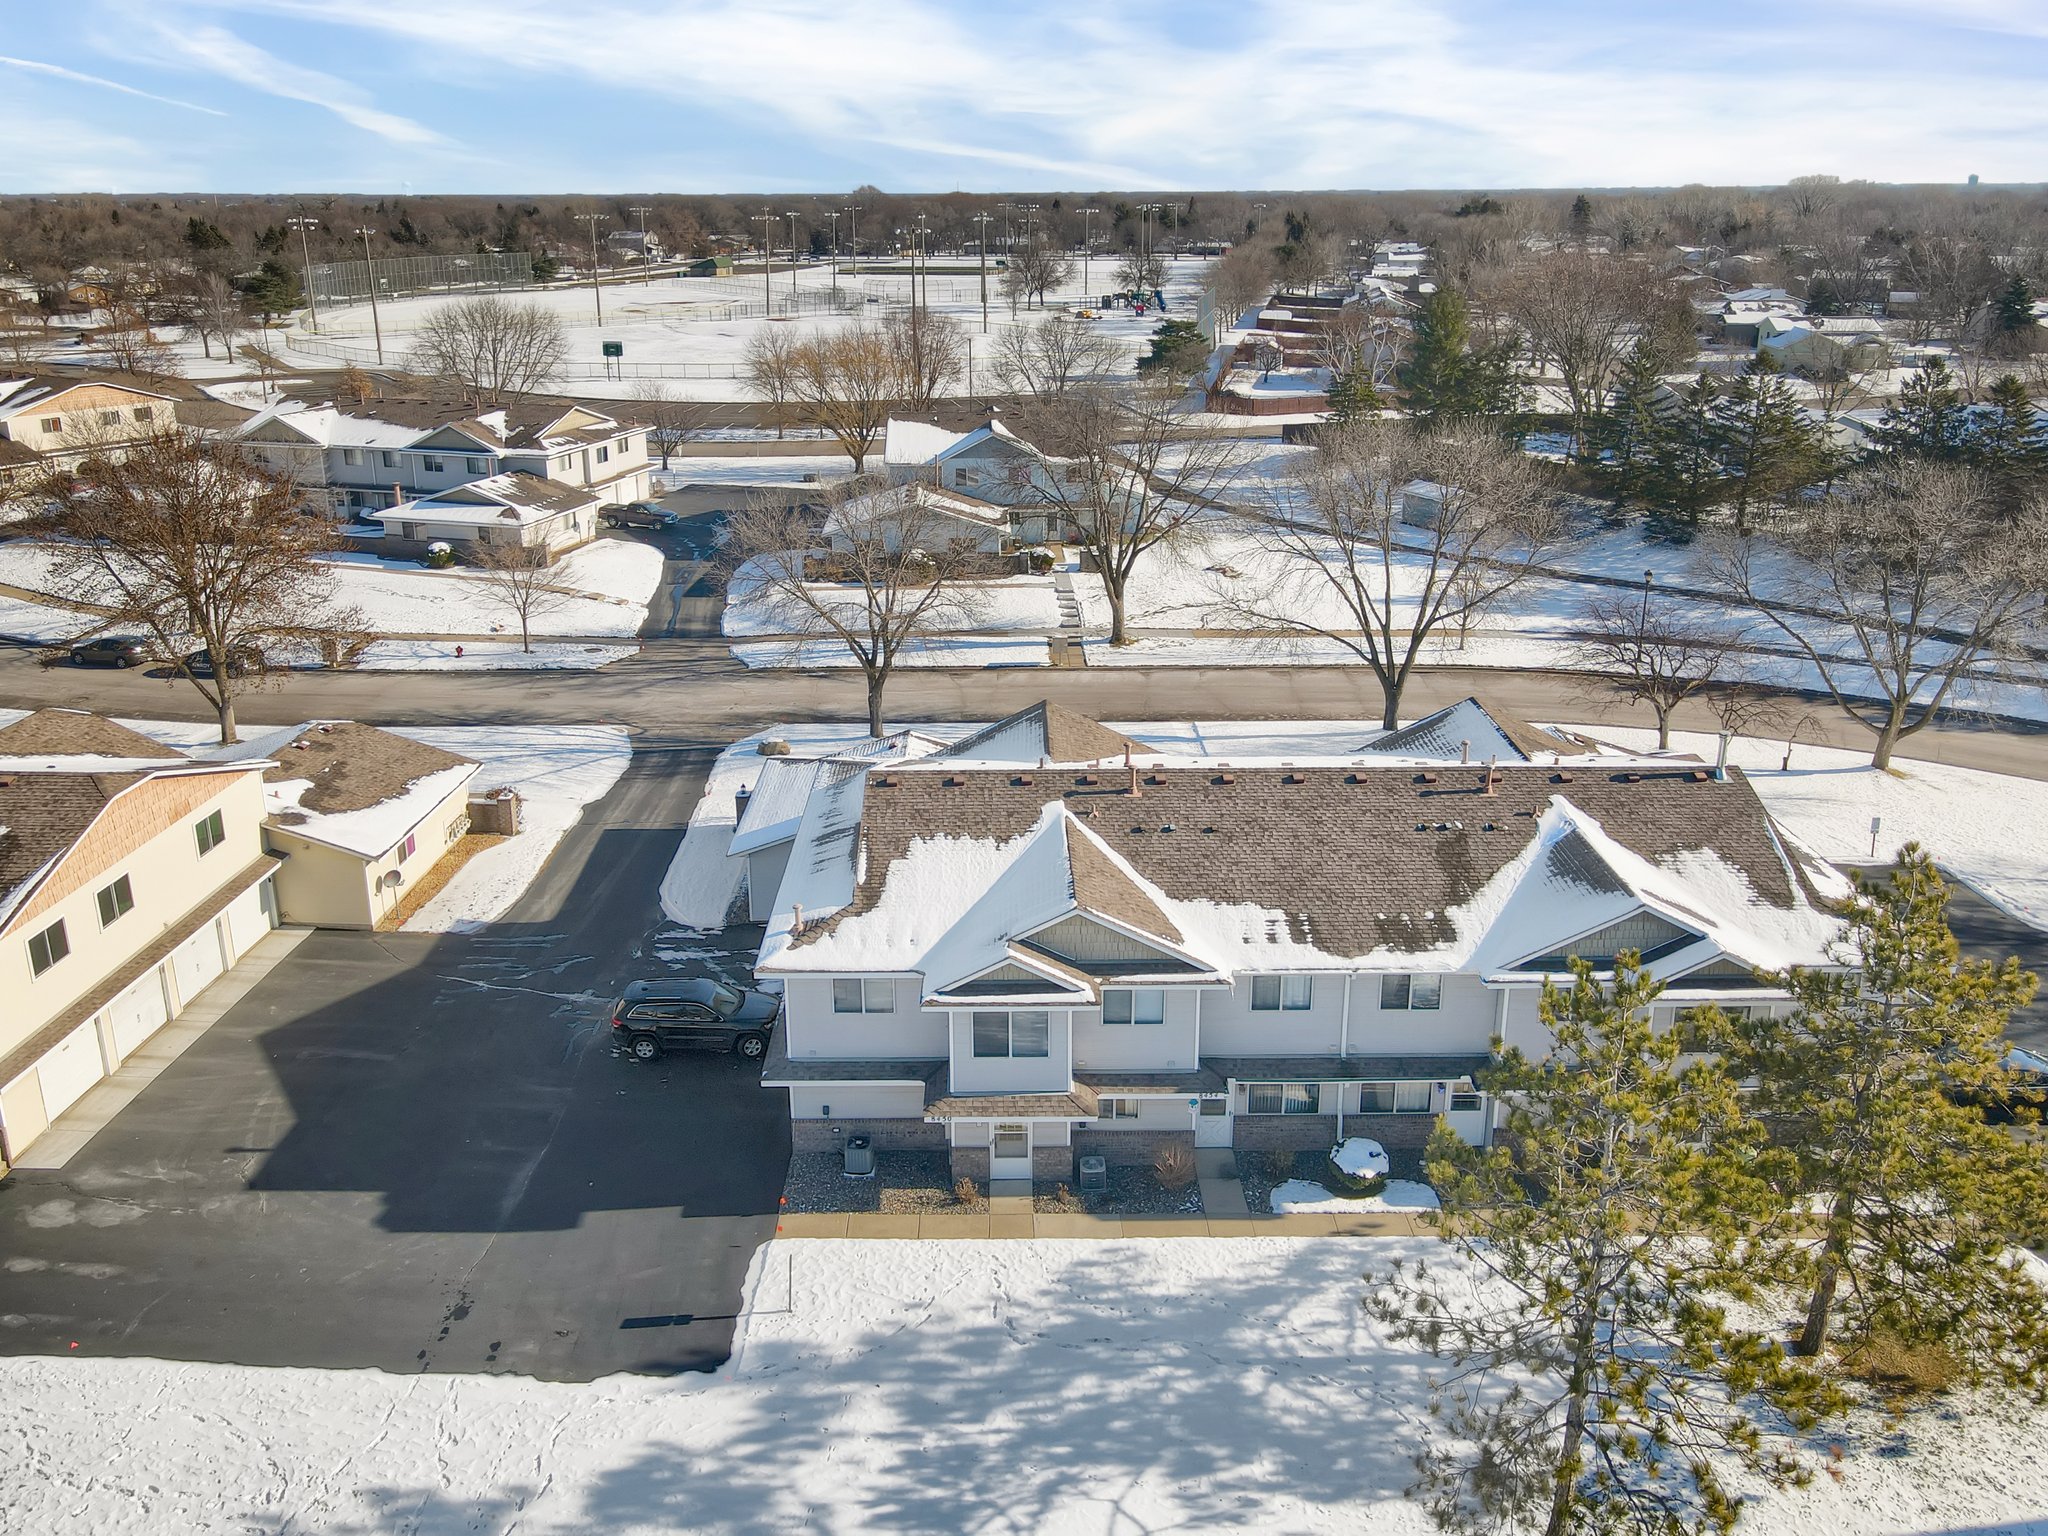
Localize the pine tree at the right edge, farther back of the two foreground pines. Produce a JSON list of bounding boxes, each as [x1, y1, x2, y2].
[[1702, 844, 2048, 1391]]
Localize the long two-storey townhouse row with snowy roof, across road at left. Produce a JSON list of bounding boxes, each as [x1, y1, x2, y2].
[[236, 399, 649, 512]]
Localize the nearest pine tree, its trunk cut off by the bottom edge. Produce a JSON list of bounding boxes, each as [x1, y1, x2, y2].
[[1366, 954, 1839, 1536]]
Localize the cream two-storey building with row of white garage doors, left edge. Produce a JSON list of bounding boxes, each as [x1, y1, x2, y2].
[[0, 709, 279, 1165]]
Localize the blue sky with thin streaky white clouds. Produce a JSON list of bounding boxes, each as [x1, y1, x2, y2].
[[0, 0, 2048, 193]]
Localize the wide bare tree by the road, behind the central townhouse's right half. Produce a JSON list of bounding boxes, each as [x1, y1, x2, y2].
[[1219, 418, 1561, 729]]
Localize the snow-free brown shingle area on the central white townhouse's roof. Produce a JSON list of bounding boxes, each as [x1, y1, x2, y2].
[[795, 764, 1798, 954]]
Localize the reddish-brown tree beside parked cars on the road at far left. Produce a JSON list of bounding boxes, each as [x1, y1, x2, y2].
[[31, 432, 356, 743]]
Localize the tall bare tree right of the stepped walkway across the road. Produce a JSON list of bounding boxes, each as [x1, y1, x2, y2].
[[1044, 383, 1239, 645]]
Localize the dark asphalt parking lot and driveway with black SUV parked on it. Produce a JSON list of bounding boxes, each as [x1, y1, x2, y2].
[[0, 743, 788, 1380]]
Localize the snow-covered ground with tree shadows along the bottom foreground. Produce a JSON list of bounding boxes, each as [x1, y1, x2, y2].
[[0, 1237, 2048, 1536]]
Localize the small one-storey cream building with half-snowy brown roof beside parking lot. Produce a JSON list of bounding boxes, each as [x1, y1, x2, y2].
[[262, 721, 477, 928]]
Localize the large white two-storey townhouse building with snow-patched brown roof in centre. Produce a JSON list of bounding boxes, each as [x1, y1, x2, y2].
[[756, 700, 1847, 1180]]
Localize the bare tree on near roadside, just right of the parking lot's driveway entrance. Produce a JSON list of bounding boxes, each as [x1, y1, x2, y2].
[[725, 477, 987, 737]]
